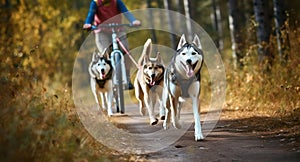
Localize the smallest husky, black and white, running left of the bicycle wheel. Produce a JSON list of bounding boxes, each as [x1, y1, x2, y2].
[[89, 51, 113, 116]]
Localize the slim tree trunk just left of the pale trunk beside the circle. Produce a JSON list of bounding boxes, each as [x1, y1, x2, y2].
[[211, 0, 223, 51]]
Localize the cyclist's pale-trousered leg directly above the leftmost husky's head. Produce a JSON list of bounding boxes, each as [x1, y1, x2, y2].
[[95, 32, 111, 55]]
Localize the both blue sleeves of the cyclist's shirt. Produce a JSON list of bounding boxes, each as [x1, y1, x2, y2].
[[85, 0, 136, 24]]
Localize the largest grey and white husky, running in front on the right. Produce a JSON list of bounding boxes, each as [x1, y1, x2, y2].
[[163, 35, 204, 141]]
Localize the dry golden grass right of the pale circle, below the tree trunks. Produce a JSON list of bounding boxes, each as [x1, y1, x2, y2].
[[221, 21, 300, 149]]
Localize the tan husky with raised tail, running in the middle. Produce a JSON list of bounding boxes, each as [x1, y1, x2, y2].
[[134, 39, 165, 125]]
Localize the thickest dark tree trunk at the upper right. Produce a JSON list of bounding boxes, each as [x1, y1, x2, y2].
[[253, 0, 271, 63]]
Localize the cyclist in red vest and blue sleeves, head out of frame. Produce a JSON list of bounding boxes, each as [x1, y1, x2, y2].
[[83, 0, 141, 89]]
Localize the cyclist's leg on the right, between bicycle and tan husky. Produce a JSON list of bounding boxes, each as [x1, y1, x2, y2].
[[118, 32, 133, 89]]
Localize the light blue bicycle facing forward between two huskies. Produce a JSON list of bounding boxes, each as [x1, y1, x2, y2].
[[87, 23, 137, 114]]
